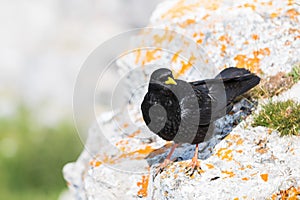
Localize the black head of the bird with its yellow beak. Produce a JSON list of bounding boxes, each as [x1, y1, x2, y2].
[[150, 68, 177, 88]]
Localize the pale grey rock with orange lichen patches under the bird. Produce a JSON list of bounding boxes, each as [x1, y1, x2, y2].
[[63, 0, 300, 200]]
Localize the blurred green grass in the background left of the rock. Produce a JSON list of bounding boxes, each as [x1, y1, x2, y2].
[[0, 106, 82, 200]]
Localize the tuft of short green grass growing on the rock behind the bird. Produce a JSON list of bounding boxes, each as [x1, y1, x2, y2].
[[253, 100, 300, 136]]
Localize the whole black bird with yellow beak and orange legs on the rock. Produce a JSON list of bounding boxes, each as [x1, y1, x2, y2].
[[141, 67, 260, 174]]
